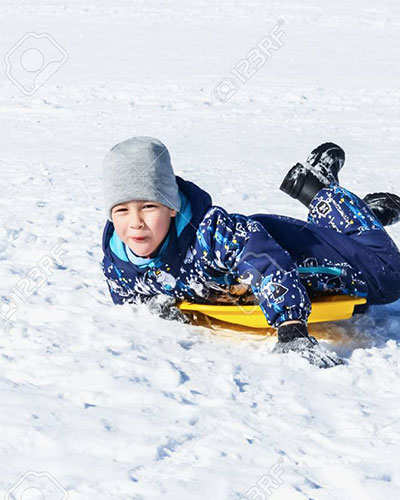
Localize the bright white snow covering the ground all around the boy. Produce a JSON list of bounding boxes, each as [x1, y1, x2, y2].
[[0, 0, 400, 500]]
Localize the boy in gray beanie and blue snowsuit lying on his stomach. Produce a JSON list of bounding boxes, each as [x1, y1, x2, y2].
[[103, 137, 400, 367]]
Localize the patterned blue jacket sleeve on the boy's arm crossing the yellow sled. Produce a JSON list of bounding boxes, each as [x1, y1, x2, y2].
[[197, 207, 311, 328]]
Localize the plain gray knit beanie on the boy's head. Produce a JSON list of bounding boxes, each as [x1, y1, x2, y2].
[[103, 136, 181, 222]]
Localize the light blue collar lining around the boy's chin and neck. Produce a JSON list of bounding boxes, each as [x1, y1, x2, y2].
[[110, 191, 193, 266]]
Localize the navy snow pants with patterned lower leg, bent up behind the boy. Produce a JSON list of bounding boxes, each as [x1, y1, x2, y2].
[[250, 183, 400, 306]]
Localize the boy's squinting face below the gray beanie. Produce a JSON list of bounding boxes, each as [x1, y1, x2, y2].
[[111, 201, 176, 257]]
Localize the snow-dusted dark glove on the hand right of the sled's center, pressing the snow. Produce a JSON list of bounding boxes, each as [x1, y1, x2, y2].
[[272, 323, 343, 368]]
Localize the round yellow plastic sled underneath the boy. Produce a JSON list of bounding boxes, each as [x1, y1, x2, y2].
[[179, 295, 367, 328]]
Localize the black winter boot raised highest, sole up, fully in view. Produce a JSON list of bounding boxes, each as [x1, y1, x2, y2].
[[279, 142, 345, 208]]
